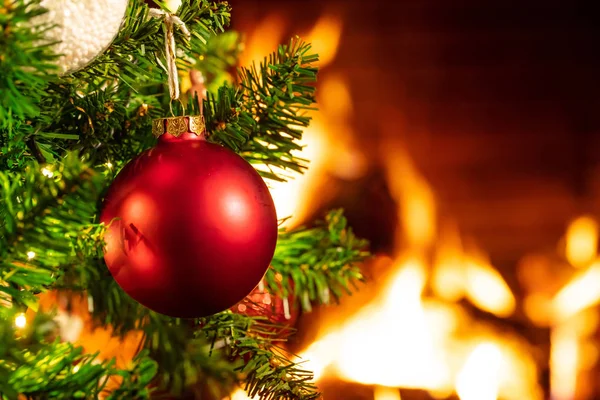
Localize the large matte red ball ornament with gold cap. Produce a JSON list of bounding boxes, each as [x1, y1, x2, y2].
[[100, 117, 277, 318]]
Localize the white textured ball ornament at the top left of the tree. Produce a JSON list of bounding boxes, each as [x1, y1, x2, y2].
[[32, 0, 128, 74]]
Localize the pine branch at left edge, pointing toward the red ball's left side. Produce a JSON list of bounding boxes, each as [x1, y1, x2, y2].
[[0, 154, 103, 307]]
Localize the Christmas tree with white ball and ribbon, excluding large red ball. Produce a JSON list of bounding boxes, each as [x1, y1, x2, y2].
[[0, 0, 367, 399]]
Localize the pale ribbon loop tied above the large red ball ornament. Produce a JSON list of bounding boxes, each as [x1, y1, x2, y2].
[[150, 8, 191, 106]]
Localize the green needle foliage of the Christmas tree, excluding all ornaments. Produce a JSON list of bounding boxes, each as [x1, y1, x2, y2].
[[0, 0, 366, 400]]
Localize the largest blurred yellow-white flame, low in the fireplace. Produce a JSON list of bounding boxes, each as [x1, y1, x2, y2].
[[302, 162, 543, 400]]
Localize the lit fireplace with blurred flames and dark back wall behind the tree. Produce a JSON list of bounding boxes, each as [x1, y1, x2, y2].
[[227, 0, 600, 400]]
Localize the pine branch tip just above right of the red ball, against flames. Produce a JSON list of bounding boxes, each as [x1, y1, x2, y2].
[[205, 38, 318, 180]]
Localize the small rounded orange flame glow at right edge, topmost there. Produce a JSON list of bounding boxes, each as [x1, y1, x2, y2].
[[565, 216, 598, 267]]
